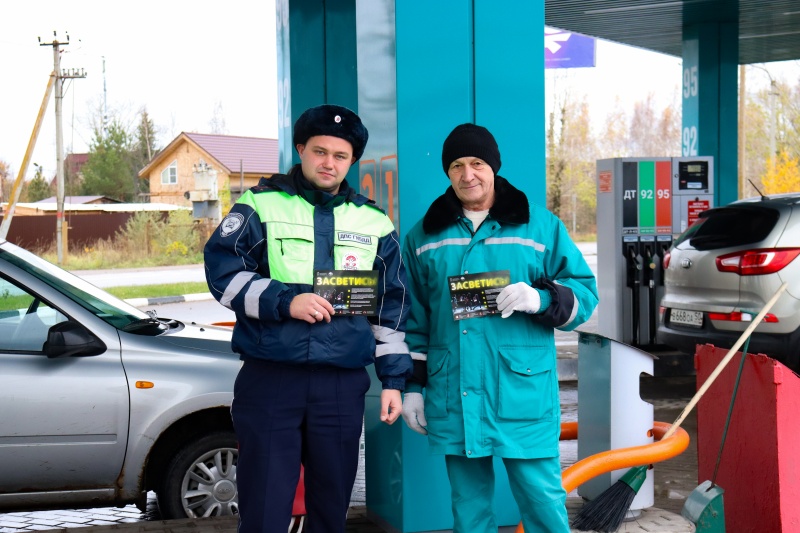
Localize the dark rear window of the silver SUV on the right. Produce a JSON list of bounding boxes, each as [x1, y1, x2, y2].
[[675, 207, 779, 251]]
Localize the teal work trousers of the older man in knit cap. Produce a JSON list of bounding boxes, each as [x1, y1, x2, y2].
[[445, 455, 570, 533]]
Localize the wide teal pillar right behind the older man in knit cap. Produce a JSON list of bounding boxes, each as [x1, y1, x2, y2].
[[357, 0, 545, 532]]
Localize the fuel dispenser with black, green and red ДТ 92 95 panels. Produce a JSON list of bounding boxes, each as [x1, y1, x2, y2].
[[597, 157, 714, 349]]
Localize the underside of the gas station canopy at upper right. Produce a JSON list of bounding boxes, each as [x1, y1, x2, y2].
[[545, 0, 800, 65]]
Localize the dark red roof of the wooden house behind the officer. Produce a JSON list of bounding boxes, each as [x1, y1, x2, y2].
[[184, 132, 278, 174]]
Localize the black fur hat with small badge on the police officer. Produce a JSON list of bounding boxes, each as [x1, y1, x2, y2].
[[292, 104, 369, 160]]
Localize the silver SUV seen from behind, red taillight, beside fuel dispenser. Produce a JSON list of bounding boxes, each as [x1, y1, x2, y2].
[[657, 193, 800, 372]]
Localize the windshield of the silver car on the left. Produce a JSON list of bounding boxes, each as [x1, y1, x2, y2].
[[0, 241, 150, 329]]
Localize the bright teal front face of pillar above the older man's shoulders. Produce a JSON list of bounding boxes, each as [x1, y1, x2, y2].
[[396, 0, 546, 233]]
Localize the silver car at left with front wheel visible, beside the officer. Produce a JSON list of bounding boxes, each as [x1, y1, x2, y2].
[[0, 239, 239, 519]]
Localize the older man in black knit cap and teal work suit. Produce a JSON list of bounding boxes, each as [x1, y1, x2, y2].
[[403, 124, 597, 533]]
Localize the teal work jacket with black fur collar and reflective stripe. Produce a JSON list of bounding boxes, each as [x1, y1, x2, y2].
[[403, 176, 597, 459]]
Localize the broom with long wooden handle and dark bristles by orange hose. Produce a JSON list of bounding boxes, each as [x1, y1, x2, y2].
[[571, 282, 788, 533]]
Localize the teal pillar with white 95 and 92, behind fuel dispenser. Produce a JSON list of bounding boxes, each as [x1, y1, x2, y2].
[[681, 22, 739, 206]]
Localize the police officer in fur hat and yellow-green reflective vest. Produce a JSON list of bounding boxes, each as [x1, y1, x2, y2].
[[205, 105, 412, 533]]
